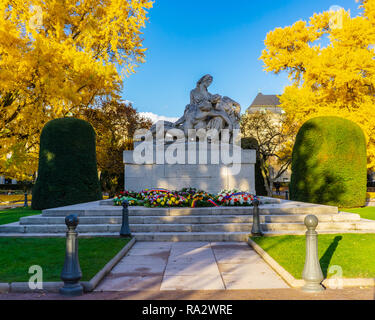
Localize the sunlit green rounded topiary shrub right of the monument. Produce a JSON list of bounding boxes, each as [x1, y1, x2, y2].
[[290, 117, 367, 207]]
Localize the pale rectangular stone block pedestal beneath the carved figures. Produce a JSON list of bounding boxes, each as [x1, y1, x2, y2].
[[124, 144, 256, 193]]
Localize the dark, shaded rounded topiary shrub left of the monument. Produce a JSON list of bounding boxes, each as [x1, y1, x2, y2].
[[32, 118, 102, 210]]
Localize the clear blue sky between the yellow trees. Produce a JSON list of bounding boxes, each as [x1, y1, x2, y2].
[[123, 0, 359, 117]]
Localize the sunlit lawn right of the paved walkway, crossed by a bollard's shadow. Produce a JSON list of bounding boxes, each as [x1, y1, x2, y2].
[[252, 234, 375, 279]]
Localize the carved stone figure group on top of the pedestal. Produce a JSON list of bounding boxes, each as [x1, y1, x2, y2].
[[151, 74, 241, 142]]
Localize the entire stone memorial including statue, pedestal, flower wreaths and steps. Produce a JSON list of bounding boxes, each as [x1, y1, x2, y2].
[[0, 75, 375, 242]]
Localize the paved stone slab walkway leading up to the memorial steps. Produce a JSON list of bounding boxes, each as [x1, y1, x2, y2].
[[96, 242, 289, 292]]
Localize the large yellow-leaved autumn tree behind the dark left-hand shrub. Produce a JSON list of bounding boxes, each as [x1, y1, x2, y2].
[[0, 0, 152, 180]]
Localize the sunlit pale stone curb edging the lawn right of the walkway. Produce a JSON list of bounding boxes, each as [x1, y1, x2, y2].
[[247, 238, 375, 289]]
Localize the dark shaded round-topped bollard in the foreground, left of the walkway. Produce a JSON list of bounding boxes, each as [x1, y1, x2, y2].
[[60, 214, 83, 297]]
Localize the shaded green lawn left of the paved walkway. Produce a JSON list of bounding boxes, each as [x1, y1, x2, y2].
[[0, 238, 129, 282]]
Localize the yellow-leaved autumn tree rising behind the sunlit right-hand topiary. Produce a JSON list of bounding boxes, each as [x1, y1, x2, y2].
[[260, 0, 375, 170]]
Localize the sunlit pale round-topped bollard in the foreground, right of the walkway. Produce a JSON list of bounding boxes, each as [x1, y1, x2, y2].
[[302, 215, 324, 292]]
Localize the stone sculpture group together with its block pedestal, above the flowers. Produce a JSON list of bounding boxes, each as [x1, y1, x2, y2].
[[124, 75, 256, 194]]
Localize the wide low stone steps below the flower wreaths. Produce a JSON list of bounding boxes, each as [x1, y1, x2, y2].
[[0, 197, 375, 241]]
